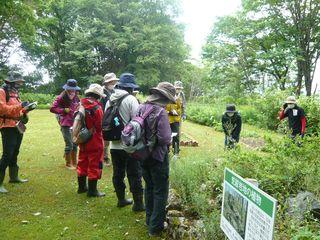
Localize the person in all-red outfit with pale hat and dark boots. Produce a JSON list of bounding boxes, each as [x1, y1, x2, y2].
[[77, 84, 106, 197]]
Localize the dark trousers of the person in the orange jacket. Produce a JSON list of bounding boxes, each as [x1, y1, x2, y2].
[[0, 127, 23, 173]]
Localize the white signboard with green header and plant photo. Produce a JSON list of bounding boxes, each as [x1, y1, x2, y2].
[[220, 168, 277, 240]]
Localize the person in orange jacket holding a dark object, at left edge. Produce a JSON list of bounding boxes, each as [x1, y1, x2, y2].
[[0, 72, 35, 193]]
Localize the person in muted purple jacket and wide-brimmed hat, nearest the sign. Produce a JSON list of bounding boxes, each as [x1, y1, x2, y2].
[[139, 82, 176, 236]]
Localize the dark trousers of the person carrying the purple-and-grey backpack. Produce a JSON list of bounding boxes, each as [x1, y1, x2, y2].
[[142, 154, 169, 233]]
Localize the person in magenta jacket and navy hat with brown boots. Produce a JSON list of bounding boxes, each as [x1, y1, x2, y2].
[[50, 79, 80, 169]]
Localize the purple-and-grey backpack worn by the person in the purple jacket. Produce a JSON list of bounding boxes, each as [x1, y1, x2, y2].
[[121, 105, 155, 160]]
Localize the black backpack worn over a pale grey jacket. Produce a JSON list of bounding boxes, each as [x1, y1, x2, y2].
[[102, 94, 129, 141]]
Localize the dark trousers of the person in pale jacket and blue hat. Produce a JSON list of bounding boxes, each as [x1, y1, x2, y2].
[[110, 149, 143, 194]]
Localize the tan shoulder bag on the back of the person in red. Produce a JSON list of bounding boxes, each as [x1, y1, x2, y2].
[[72, 104, 99, 144]]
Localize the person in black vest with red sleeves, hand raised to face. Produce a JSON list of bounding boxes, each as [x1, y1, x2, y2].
[[279, 96, 307, 138]]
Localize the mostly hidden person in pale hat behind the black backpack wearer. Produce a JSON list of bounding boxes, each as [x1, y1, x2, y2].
[[101, 73, 119, 167]]
